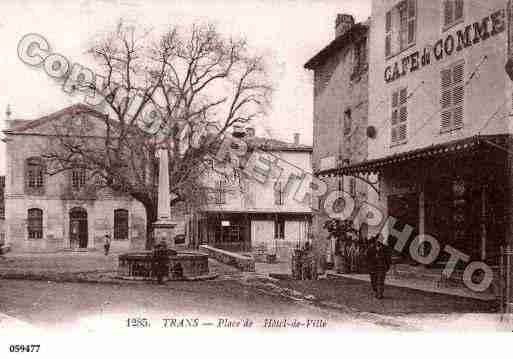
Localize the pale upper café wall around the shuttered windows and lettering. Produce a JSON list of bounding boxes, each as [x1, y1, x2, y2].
[[369, 0, 511, 159]]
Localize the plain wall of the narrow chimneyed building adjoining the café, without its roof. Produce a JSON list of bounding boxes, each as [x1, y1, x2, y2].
[[313, 23, 368, 260]]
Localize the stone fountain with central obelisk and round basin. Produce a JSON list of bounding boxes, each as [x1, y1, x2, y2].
[[118, 148, 216, 280]]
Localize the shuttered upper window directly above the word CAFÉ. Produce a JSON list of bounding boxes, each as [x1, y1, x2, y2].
[[385, 0, 417, 57]]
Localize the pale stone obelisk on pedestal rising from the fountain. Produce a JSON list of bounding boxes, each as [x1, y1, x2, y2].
[[153, 147, 176, 248]]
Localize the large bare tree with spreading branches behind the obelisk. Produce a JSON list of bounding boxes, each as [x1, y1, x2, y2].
[[45, 21, 271, 245]]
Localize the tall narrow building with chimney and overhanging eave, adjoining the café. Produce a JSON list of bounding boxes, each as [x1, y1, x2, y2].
[[305, 14, 369, 257]]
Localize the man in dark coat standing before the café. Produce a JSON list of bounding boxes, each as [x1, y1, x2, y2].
[[367, 236, 391, 299]]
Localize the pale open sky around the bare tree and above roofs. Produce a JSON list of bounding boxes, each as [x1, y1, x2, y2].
[[0, 0, 370, 174]]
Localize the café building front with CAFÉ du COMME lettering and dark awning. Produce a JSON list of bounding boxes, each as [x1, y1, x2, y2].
[[336, 0, 512, 266]]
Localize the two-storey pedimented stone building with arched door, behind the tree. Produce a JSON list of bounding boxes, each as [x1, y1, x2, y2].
[[4, 104, 146, 252]]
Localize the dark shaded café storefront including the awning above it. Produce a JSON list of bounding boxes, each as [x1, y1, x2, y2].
[[341, 135, 511, 266]]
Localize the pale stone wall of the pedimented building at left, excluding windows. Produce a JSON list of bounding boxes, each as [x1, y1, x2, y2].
[[6, 116, 146, 251]]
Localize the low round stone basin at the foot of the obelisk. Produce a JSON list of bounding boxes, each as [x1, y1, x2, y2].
[[118, 250, 216, 280]]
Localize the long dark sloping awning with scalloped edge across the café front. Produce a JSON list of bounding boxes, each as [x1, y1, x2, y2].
[[316, 134, 512, 177]]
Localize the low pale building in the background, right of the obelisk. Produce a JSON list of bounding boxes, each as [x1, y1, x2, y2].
[[188, 129, 312, 258]]
